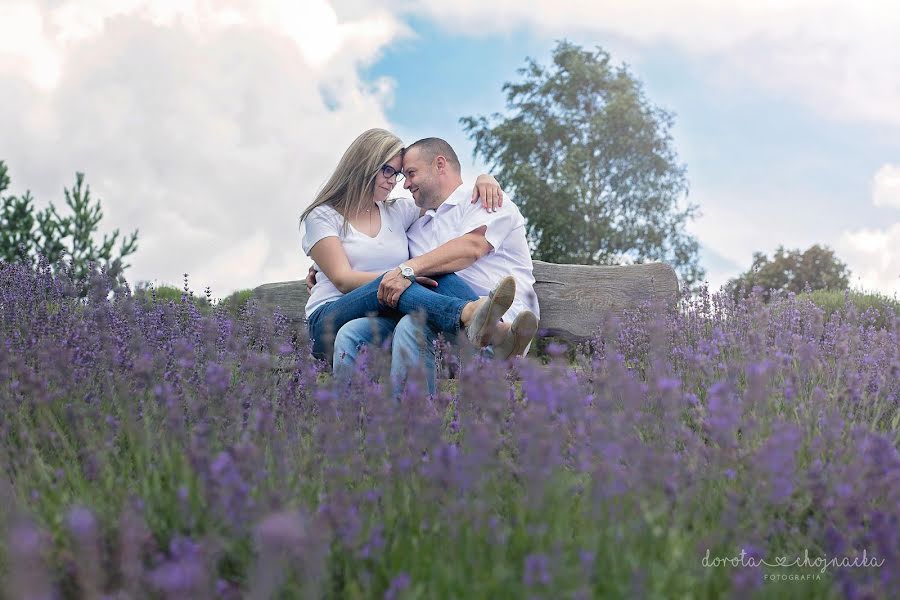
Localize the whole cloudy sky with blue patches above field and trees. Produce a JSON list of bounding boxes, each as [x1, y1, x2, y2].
[[0, 0, 900, 296]]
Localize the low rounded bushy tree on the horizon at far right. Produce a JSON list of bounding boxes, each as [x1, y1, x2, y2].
[[725, 244, 850, 299]]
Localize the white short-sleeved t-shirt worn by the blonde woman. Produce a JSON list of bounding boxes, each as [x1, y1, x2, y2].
[[300, 198, 419, 318]]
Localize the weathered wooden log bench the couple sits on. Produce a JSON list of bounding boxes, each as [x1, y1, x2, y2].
[[253, 260, 679, 342]]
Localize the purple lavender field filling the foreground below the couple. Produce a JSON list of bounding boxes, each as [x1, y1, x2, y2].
[[0, 264, 900, 599]]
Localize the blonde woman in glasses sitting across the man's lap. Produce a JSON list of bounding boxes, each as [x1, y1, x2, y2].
[[300, 129, 515, 359]]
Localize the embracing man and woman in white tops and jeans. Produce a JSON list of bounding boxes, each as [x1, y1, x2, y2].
[[300, 129, 539, 394]]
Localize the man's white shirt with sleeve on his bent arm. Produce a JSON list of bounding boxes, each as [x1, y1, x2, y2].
[[406, 185, 540, 322]]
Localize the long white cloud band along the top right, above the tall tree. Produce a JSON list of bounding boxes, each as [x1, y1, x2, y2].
[[404, 0, 900, 127]]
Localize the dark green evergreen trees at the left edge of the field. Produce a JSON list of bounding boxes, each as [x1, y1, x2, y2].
[[0, 161, 138, 281]]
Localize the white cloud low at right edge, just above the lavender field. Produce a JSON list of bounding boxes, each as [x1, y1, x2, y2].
[[836, 221, 900, 298]]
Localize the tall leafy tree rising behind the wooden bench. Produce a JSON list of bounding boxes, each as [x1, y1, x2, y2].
[[460, 40, 704, 284]]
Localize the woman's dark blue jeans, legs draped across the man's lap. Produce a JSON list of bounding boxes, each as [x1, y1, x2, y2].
[[307, 273, 478, 359]]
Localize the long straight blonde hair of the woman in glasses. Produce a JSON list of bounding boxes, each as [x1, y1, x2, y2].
[[300, 129, 403, 232]]
